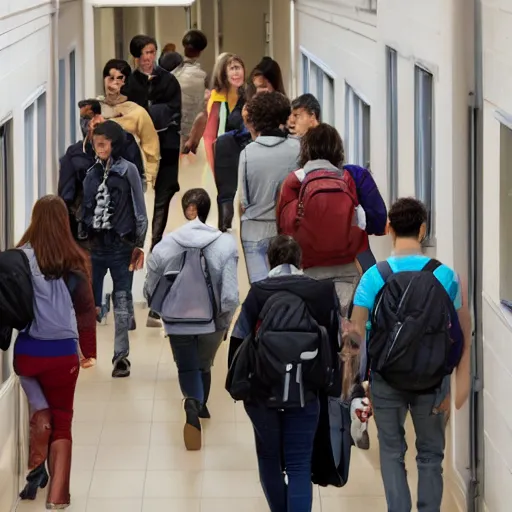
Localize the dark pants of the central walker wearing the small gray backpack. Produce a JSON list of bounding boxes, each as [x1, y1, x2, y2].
[[169, 331, 224, 403]]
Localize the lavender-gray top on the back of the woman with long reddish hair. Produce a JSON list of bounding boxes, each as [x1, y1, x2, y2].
[[22, 245, 78, 340]]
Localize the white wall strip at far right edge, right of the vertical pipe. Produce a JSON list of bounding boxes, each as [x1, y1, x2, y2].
[[482, 0, 512, 512]]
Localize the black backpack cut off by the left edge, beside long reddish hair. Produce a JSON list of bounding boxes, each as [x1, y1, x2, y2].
[[0, 249, 34, 350]]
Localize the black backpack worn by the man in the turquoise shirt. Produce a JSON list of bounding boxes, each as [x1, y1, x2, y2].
[[368, 259, 463, 393]]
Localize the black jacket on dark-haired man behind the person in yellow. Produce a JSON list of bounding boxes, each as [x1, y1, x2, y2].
[[122, 66, 181, 150]]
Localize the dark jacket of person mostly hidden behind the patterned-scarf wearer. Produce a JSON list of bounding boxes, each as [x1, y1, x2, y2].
[[58, 136, 146, 238]]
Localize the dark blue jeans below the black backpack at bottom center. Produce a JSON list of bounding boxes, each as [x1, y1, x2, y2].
[[245, 400, 320, 512]]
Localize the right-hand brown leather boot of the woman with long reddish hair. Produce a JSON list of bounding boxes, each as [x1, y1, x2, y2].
[[46, 439, 72, 510]]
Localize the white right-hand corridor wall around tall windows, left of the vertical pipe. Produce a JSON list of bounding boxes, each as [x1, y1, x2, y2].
[[296, 0, 472, 509]]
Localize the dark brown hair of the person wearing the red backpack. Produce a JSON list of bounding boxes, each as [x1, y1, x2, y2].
[[299, 123, 345, 167]]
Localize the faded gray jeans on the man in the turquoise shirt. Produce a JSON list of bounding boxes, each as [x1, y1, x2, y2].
[[371, 374, 445, 512]]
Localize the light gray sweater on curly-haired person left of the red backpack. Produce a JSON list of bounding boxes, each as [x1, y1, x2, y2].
[[238, 136, 300, 242]]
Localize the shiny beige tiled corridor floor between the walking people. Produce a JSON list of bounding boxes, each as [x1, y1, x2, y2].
[[17, 146, 462, 512]]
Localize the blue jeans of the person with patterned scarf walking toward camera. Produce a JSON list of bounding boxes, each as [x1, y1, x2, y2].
[[91, 241, 134, 361]]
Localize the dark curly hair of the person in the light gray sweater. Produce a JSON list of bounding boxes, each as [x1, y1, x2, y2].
[[247, 92, 291, 133]]
